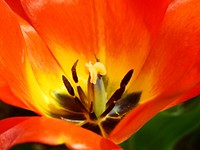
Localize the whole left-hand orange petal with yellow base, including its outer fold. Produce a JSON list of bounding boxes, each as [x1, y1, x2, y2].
[[0, 2, 67, 113]]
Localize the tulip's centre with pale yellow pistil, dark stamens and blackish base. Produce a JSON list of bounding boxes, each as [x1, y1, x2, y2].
[[54, 60, 141, 137]]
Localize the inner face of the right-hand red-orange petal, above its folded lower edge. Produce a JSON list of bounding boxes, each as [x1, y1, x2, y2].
[[131, 0, 200, 102]]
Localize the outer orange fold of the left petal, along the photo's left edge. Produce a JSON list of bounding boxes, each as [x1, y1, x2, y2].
[[0, 1, 53, 112]]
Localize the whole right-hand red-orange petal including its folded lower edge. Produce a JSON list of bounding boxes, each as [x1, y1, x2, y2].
[[111, 0, 200, 142]]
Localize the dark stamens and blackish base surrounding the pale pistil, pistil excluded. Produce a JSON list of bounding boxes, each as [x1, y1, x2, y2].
[[52, 61, 142, 137]]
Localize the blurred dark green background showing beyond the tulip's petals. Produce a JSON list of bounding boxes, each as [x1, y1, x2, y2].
[[0, 96, 200, 150]]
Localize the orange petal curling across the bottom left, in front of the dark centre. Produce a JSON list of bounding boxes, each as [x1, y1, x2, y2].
[[0, 117, 121, 150]]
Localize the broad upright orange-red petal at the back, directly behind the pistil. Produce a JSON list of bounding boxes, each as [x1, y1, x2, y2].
[[21, 0, 169, 91]]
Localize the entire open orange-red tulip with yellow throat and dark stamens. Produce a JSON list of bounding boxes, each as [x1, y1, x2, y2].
[[0, 0, 200, 150]]
